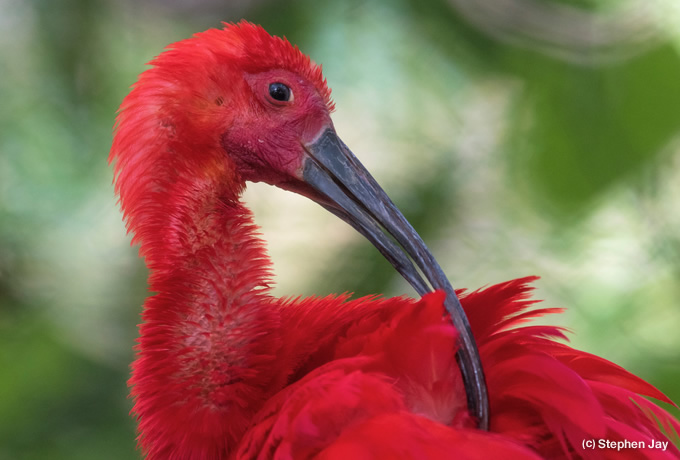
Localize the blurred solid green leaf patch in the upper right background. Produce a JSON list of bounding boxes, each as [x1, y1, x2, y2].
[[509, 45, 680, 214]]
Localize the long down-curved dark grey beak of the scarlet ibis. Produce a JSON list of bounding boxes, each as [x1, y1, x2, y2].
[[302, 128, 489, 429]]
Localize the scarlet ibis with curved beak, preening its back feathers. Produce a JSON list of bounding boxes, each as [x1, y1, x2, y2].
[[110, 22, 680, 460]]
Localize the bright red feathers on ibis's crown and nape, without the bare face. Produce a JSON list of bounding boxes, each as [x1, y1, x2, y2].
[[109, 21, 333, 252]]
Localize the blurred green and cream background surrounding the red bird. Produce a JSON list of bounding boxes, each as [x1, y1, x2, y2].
[[0, 0, 680, 460]]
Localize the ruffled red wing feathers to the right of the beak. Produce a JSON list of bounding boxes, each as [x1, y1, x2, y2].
[[461, 277, 680, 458]]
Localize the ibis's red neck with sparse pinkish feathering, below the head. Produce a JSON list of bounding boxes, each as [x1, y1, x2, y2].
[[130, 183, 285, 458]]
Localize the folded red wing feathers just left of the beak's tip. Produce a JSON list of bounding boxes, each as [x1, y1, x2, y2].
[[237, 293, 537, 459]]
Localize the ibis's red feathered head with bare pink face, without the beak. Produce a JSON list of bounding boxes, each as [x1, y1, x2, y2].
[[111, 22, 333, 199]]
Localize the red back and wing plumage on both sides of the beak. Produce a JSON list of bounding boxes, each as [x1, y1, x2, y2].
[[242, 277, 680, 459]]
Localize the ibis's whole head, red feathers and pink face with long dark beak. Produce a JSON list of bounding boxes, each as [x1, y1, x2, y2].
[[110, 18, 486, 428]]
